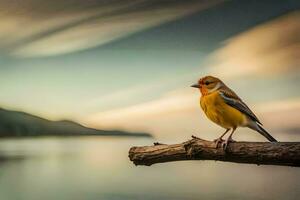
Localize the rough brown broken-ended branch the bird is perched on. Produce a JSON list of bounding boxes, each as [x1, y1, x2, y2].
[[129, 137, 300, 167]]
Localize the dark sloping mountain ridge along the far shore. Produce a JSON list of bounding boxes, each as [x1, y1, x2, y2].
[[0, 108, 151, 137]]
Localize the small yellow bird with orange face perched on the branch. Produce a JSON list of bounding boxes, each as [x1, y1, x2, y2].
[[191, 76, 277, 149]]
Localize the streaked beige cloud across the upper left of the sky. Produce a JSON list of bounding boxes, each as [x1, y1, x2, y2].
[[0, 0, 219, 57]]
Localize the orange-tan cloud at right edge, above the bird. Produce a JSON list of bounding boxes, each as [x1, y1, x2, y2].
[[208, 11, 300, 77]]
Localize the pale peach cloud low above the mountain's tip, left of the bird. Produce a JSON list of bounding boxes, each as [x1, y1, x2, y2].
[[79, 90, 199, 136]]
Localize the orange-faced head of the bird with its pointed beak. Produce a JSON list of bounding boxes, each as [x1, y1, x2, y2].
[[191, 76, 224, 95]]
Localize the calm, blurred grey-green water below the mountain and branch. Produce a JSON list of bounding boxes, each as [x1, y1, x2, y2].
[[0, 137, 300, 200]]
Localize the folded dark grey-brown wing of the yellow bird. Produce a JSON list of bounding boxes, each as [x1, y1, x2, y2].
[[219, 88, 262, 125]]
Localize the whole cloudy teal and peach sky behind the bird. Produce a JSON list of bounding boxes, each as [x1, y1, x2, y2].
[[0, 0, 300, 139]]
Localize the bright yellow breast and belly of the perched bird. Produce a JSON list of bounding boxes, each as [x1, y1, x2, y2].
[[200, 91, 246, 129]]
